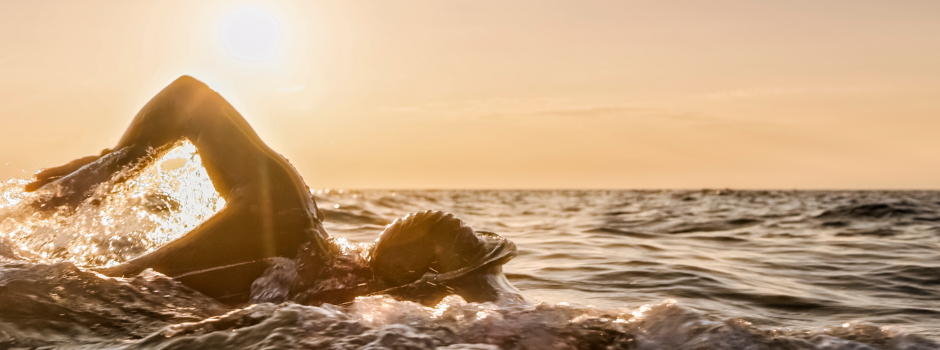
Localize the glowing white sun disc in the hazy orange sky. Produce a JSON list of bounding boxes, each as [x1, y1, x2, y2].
[[221, 7, 281, 63]]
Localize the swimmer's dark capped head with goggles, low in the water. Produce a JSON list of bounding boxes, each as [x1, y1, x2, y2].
[[372, 211, 517, 304]]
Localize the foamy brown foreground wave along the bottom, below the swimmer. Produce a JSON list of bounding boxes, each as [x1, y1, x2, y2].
[[0, 263, 940, 349]]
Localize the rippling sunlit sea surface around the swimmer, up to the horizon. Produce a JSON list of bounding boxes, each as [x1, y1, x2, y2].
[[0, 147, 940, 349]]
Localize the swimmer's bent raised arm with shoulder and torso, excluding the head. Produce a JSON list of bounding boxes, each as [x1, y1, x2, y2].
[[28, 76, 328, 296]]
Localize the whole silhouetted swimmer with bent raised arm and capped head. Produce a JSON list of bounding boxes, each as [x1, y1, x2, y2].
[[25, 76, 521, 305]]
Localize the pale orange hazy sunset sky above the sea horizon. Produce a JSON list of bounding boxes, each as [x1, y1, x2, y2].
[[0, 0, 940, 189]]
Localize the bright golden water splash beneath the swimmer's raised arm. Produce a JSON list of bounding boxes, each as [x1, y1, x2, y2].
[[0, 142, 225, 265]]
